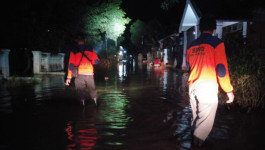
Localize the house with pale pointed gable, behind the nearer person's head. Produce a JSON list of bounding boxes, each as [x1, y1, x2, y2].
[[159, 0, 265, 70]]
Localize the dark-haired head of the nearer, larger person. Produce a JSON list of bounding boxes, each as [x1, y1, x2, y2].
[[199, 14, 216, 32]]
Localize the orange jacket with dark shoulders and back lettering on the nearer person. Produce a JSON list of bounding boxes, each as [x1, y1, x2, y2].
[[186, 33, 233, 92]]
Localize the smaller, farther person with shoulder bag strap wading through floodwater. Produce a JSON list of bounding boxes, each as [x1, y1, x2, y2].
[[65, 35, 99, 106]]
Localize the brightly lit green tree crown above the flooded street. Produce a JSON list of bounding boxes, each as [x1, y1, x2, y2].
[[84, 0, 131, 47]]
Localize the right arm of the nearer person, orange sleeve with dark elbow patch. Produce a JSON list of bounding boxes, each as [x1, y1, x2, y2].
[[214, 42, 234, 103]]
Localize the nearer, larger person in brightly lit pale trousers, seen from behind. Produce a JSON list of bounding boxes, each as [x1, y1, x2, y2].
[[186, 15, 234, 147]]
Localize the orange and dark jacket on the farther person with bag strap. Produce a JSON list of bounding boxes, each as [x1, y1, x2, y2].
[[67, 45, 99, 79]]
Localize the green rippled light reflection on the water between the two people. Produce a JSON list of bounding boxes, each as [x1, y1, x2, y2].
[[96, 84, 132, 148]]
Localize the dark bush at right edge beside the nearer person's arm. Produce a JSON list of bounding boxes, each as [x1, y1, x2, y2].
[[220, 33, 265, 111]]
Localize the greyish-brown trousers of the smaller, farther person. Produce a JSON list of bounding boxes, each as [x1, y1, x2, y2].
[[75, 75, 98, 100]]
